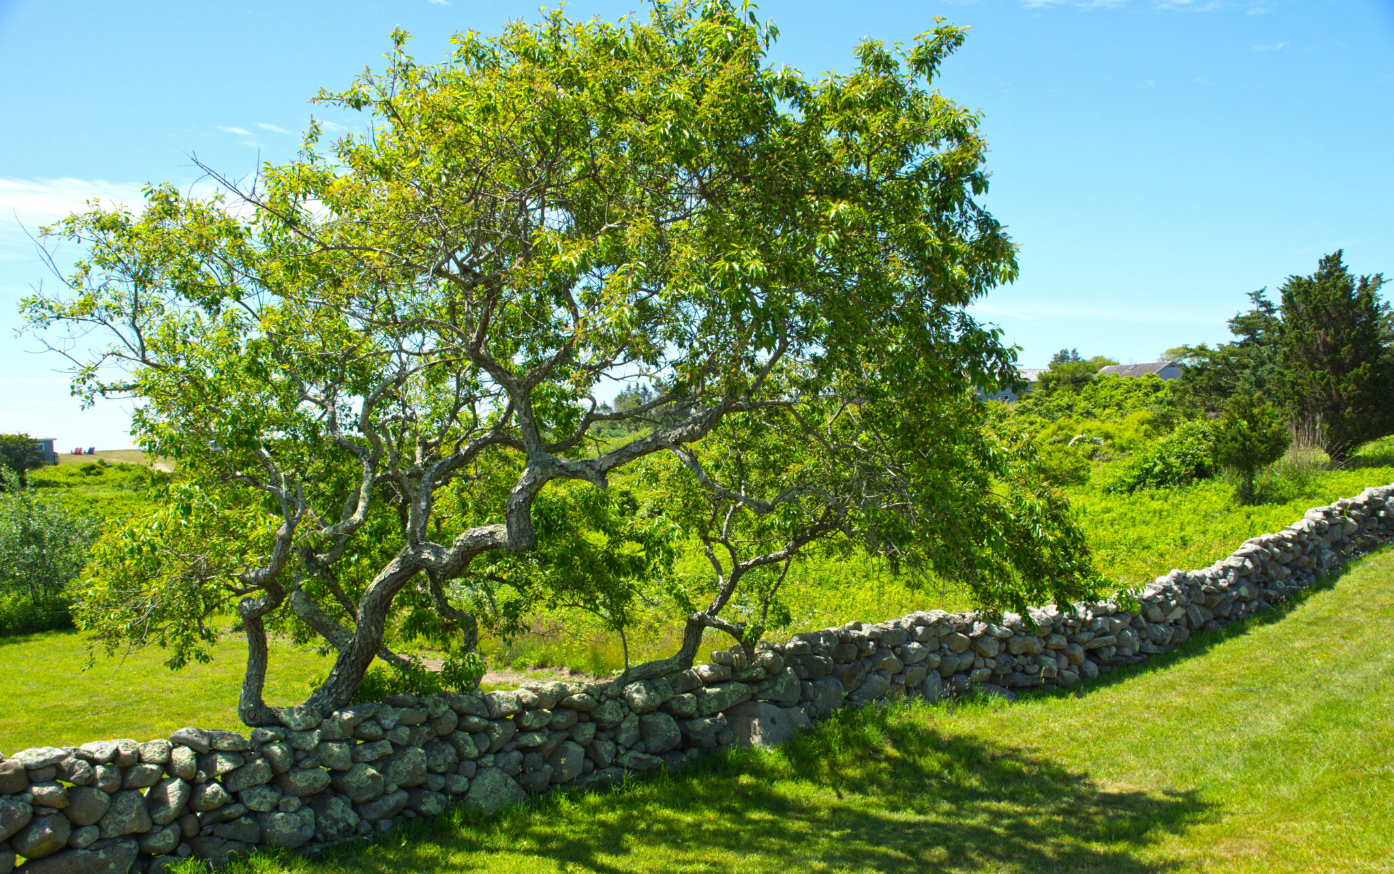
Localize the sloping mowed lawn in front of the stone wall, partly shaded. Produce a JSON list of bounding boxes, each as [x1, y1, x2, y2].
[[190, 549, 1394, 874]]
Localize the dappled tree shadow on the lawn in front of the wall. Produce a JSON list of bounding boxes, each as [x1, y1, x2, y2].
[[302, 704, 1210, 874]]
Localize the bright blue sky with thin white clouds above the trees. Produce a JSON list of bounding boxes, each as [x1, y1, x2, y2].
[[0, 0, 1394, 449]]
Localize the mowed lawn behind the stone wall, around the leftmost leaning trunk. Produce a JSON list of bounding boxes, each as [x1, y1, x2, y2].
[[0, 631, 332, 754]]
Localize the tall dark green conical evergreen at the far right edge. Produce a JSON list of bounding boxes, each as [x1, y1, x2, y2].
[[1280, 250, 1394, 464]]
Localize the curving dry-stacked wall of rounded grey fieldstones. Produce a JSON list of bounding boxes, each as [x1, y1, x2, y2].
[[0, 485, 1394, 874]]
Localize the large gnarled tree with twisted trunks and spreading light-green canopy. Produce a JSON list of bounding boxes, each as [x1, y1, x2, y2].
[[25, 0, 1096, 725]]
